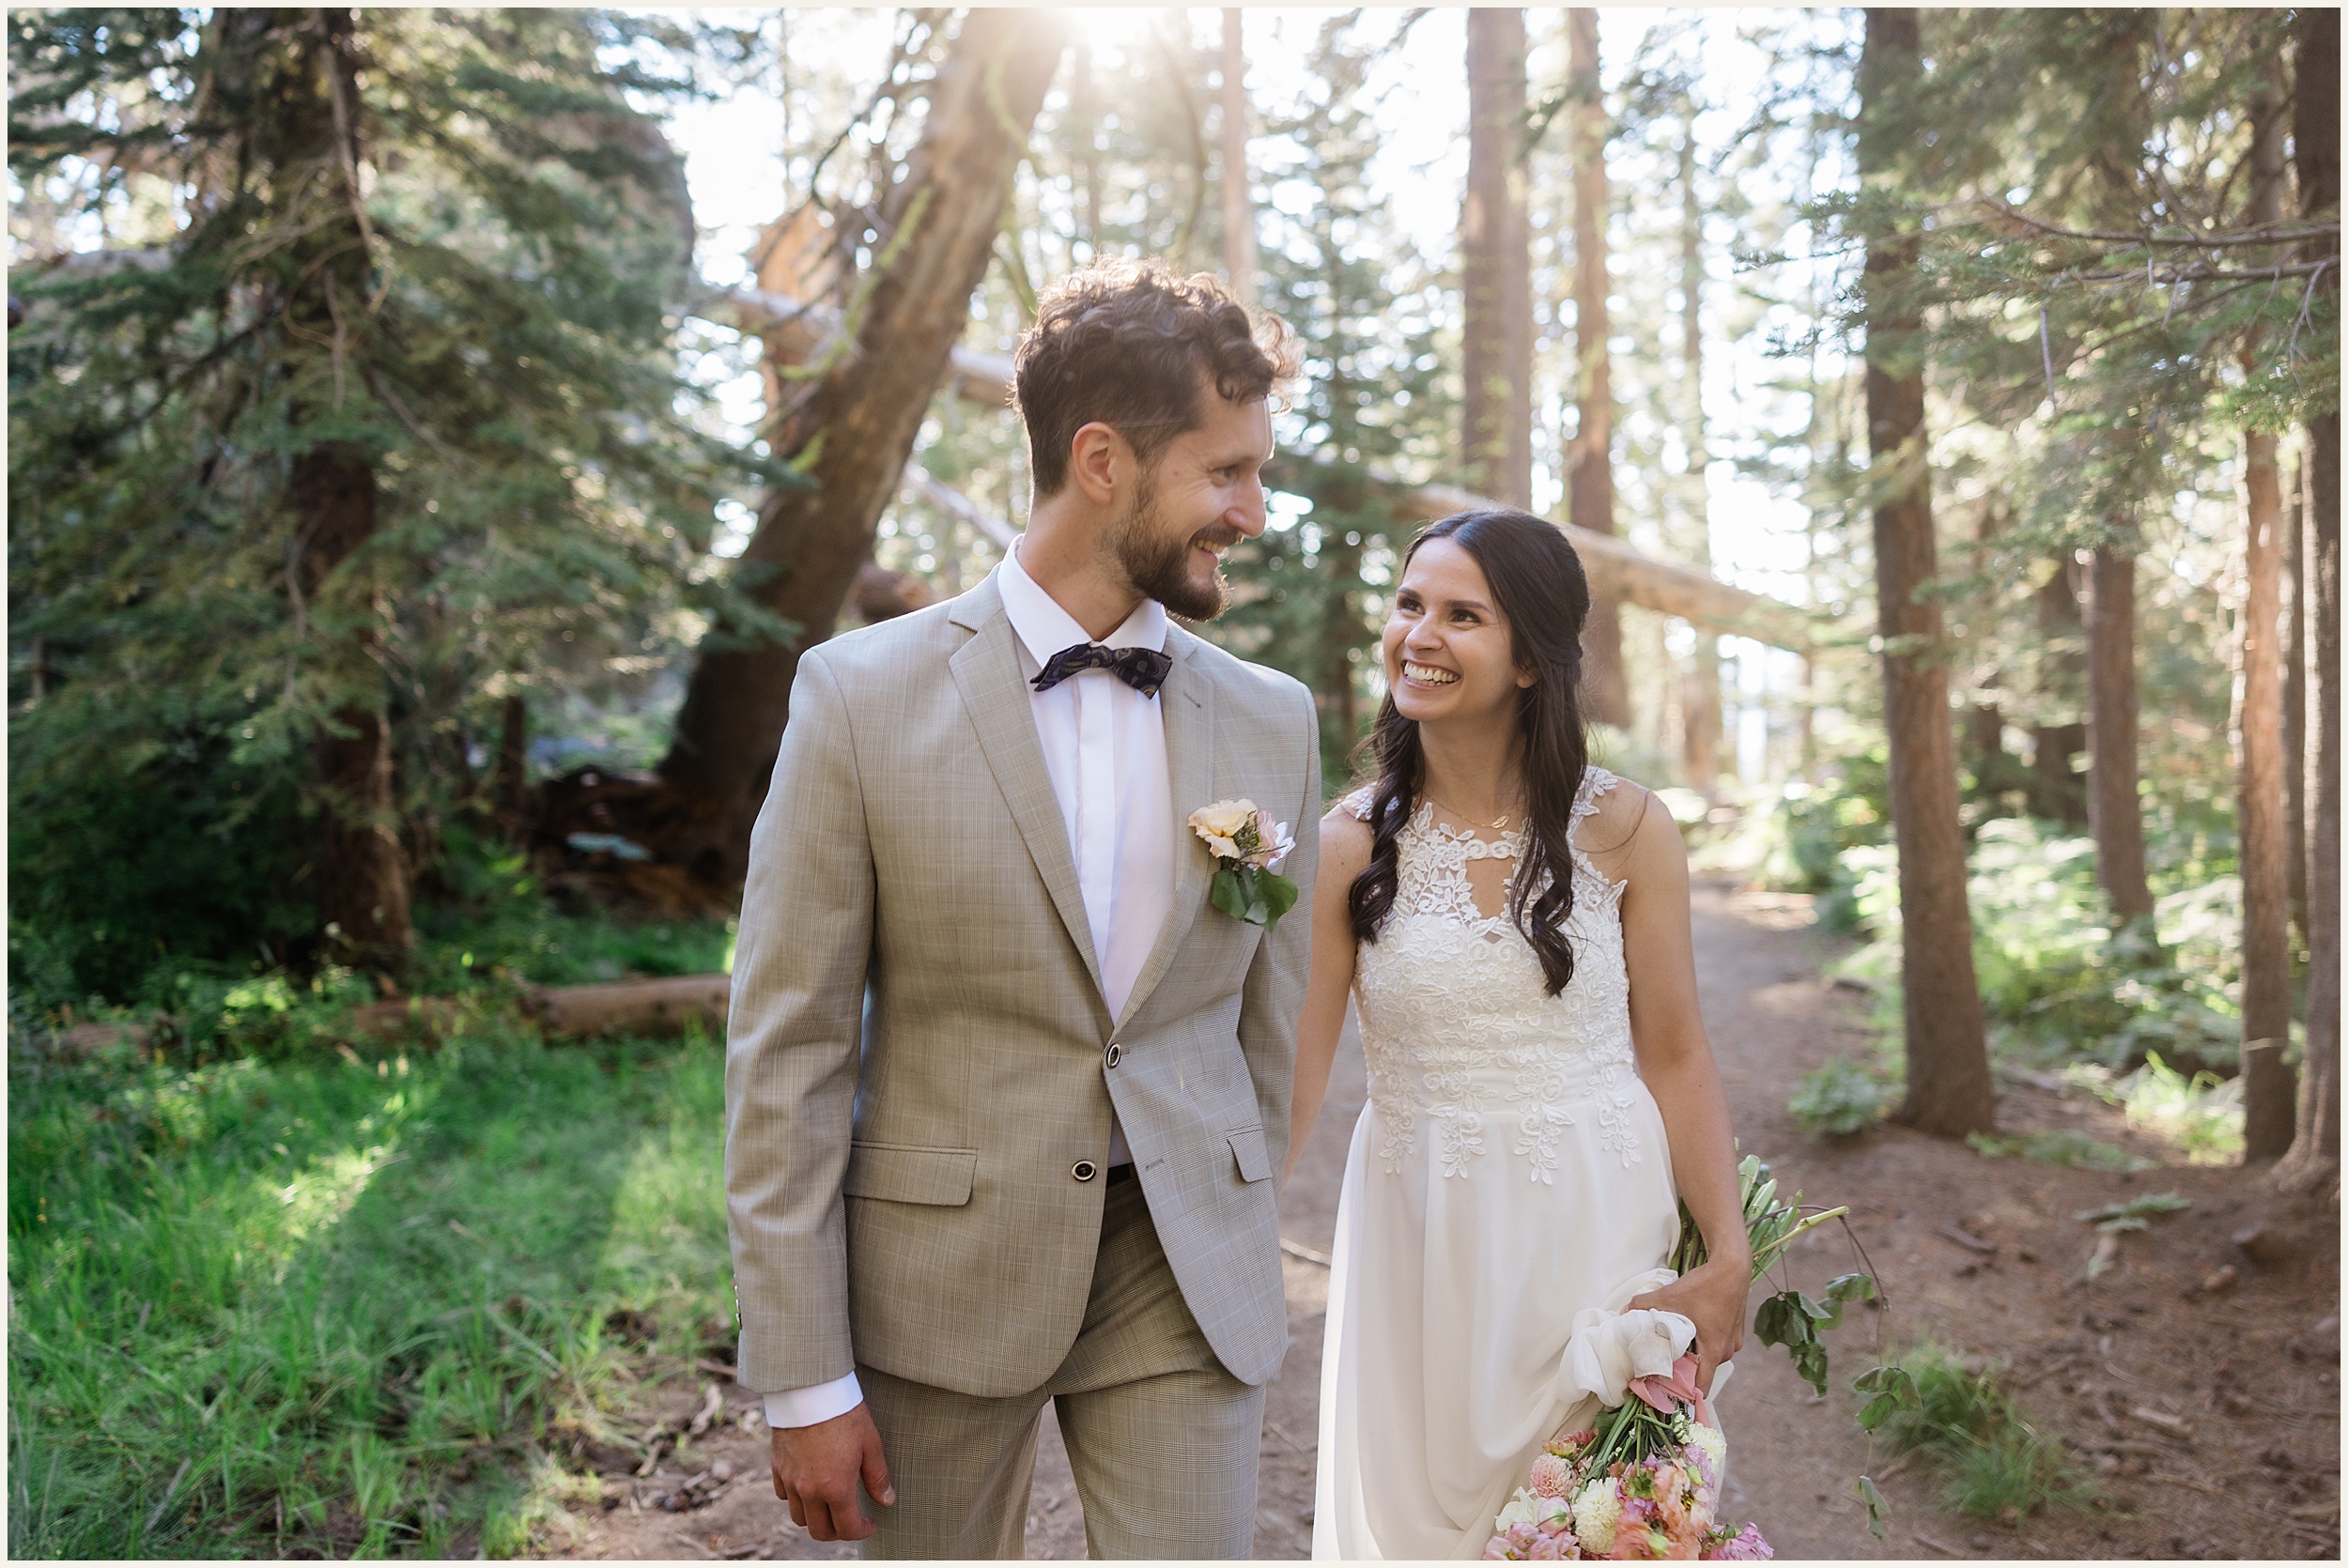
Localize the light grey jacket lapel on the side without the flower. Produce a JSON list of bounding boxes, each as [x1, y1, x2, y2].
[[947, 577, 1102, 991]]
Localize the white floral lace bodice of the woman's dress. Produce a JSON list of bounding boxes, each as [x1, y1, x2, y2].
[[1346, 768, 1642, 1183]]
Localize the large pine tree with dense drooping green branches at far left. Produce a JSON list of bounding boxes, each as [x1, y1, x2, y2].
[[9, 9, 737, 991]]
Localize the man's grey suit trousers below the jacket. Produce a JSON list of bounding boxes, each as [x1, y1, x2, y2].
[[857, 1181, 1263, 1559]]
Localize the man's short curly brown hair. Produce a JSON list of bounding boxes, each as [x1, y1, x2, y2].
[[1012, 261, 1296, 496]]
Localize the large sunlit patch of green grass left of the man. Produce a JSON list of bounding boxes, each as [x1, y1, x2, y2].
[[8, 1028, 731, 1557]]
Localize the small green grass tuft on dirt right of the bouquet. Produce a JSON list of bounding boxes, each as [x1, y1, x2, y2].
[[1881, 1345, 2094, 1521]]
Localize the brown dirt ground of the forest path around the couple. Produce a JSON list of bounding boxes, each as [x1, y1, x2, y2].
[[566, 883, 2341, 1559]]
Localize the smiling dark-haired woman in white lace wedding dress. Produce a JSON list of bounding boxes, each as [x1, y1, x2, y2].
[[1290, 510, 1752, 1559]]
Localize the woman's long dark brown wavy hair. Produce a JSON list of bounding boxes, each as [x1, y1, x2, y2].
[[1346, 521, 1590, 995]]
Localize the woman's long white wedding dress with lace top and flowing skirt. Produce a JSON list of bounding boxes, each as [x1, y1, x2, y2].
[[1313, 768, 1679, 1559]]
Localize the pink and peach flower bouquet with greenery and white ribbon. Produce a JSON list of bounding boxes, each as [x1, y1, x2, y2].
[[1484, 1158, 1877, 1561]]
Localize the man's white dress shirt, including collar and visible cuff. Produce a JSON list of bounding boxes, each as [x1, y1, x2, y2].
[[765, 549, 1174, 1427]]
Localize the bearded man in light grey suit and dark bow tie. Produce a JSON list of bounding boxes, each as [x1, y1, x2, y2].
[[726, 263, 1320, 1557]]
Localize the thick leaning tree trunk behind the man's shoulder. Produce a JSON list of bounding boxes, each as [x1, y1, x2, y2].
[[656, 9, 1061, 885]]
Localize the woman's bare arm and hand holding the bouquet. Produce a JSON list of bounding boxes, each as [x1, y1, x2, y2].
[[1615, 789, 1752, 1392]]
